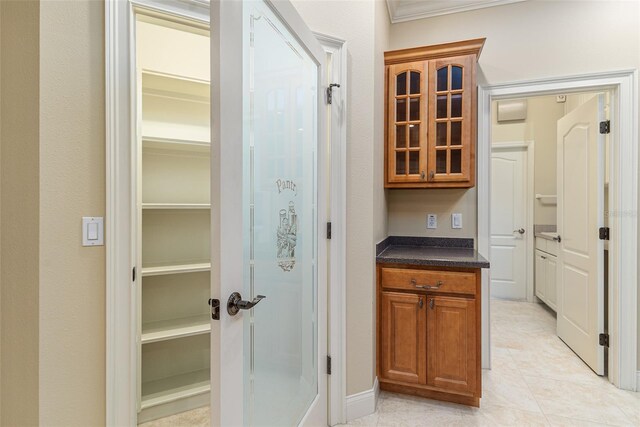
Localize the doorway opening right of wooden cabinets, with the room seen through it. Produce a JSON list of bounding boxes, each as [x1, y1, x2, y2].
[[490, 92, 611, 381]]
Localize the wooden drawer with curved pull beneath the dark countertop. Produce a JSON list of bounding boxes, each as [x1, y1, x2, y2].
[[381, 268, 476, 294]]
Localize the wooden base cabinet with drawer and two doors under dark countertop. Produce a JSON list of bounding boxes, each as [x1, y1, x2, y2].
[[377, 264, 482, 406]]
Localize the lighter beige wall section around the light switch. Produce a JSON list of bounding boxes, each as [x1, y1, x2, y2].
[[40, 1, 106, 426]]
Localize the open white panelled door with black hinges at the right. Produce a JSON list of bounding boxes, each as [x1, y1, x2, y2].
[[556, 95, 605, 375]]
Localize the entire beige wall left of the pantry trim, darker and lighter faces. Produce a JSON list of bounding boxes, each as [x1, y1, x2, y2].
[[0, 1, 105, 426]]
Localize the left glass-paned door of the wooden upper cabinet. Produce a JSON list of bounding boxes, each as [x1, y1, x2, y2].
[[387, 62, 427, 182]]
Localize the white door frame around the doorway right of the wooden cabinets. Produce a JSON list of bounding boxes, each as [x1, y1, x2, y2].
[[477, 70, 638, 390]]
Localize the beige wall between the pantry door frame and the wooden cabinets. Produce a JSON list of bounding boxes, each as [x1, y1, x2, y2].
[[293, 0, 386, 394]]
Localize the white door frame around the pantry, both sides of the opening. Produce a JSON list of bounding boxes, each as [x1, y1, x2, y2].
[[105, 0, 348, 426]]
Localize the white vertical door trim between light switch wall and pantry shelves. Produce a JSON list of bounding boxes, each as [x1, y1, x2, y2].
[[105, 0, 137, 426]]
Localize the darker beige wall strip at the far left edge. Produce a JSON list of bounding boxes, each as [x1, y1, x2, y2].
[[0, 1, 40, 426]]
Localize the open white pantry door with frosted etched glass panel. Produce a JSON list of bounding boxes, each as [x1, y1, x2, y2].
[[211, 0, 327, 426]]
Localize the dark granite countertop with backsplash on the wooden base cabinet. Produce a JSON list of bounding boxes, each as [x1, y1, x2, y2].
[[376, 236, 489, 268]]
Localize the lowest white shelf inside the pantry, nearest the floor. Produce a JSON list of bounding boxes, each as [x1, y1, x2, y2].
[[141, 369, 211, 409]]
